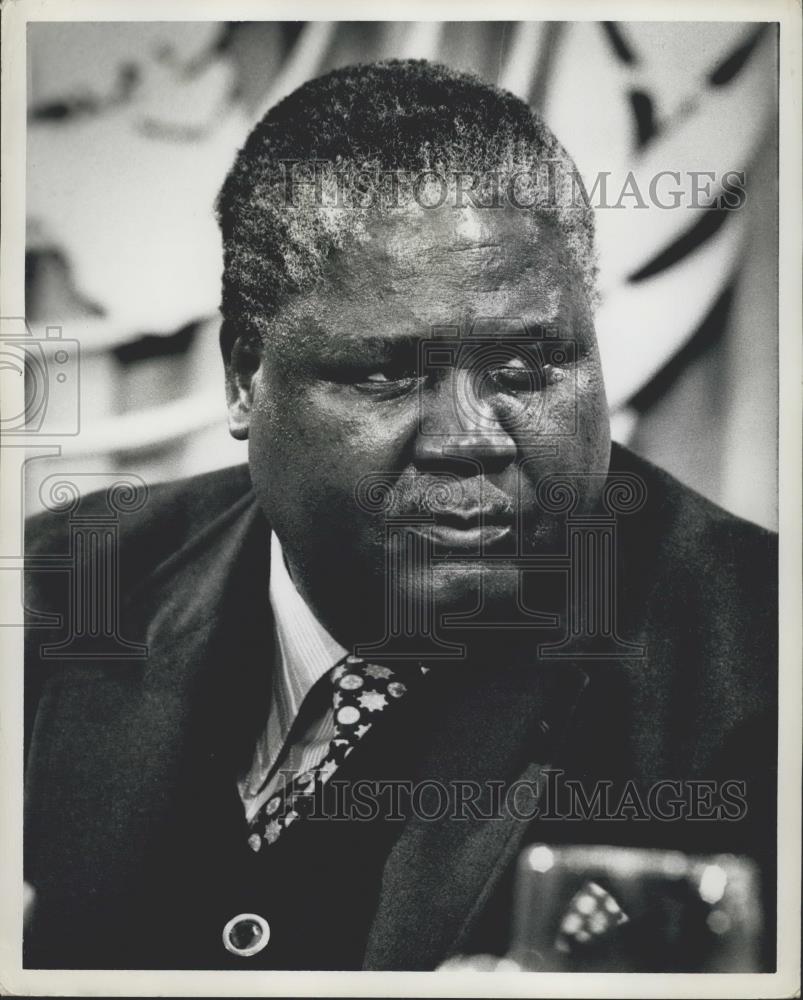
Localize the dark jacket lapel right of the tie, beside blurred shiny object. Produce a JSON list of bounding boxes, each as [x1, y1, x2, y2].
[[364, 663, 587, 970]]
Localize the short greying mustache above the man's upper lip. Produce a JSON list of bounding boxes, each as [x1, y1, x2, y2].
[[355, 472, 516, 518]]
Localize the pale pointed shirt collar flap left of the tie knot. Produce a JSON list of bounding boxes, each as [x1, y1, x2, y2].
[[270, 532, 348, 718]]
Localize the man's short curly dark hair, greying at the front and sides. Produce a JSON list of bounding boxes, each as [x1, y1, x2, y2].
[[216, 60, 596, 357]]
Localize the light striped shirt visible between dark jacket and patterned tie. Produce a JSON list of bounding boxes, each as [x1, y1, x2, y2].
[[238, 533, 348, 822]]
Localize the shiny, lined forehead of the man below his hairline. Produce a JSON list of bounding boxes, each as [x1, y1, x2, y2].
[[274, 208, 577, 333]]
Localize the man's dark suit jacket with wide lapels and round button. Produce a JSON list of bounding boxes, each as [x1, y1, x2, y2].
[[25, 448, 777, 969]]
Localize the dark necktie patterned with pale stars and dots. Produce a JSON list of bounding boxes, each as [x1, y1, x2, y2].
[[248, 656, 429, 851]]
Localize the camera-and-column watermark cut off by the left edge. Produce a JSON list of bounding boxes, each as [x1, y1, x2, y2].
[[0, 316, 148, 660]]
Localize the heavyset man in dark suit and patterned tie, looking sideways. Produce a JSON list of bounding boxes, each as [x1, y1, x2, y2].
[[25, 62, 776, 969]]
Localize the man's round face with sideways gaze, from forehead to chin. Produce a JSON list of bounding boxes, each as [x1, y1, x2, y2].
[[231, 207, 610, 645]]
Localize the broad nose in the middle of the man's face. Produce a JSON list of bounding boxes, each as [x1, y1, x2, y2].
[[416, 368, 516, 472]]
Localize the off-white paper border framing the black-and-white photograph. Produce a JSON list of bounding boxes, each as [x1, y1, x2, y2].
[[0, 0, 803, 997]]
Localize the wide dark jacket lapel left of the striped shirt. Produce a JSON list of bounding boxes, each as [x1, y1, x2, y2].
[[26, 494, 273, 912]]
